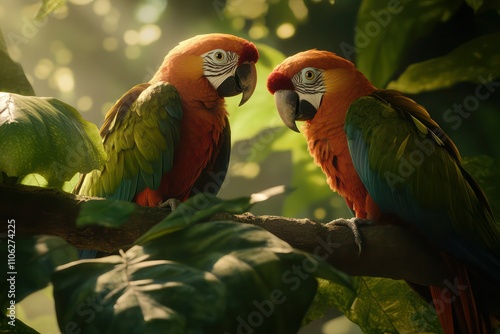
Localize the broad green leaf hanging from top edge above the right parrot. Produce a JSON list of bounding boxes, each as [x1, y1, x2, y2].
[[354, 0, 463, 88]]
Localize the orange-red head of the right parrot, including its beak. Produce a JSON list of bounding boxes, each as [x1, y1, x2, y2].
[[267, 50, 375, 132]]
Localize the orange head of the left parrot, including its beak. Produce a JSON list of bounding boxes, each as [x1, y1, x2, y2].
[[151, 34, 259, 105]]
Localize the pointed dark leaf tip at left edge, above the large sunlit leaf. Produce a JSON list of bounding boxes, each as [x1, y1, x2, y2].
[[0, 31, 35, 95]]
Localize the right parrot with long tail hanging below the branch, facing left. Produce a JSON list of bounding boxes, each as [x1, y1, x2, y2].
[[267, 50, 500, 333]]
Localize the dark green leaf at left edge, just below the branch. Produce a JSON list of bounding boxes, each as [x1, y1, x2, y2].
[[0, 235, 78, 309]]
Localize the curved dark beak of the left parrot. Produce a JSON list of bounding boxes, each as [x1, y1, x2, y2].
[[217, 62, 257, 106]]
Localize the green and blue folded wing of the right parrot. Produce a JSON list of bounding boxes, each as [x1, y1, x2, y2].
[[345, 90, 500, 254]]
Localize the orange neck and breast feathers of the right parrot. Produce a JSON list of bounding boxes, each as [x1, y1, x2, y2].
[[303, 69, 380, 220]]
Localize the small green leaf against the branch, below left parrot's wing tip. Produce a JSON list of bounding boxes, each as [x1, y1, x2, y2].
[[76, 200, 137, 228]]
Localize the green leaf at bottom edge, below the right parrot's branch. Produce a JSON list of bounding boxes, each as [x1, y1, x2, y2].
[[309, 277, 442, 334]]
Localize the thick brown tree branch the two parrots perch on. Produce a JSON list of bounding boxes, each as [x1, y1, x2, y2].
[[0, 184, 446, 285]]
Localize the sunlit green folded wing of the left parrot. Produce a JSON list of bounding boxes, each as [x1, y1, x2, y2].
[[76, 82, 182, 201]]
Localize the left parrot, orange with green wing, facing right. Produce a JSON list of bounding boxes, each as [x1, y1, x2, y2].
[[75, 34, 259, 256]]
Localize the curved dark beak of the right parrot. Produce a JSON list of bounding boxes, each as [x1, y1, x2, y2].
[[274, 89, 317, 132]]
